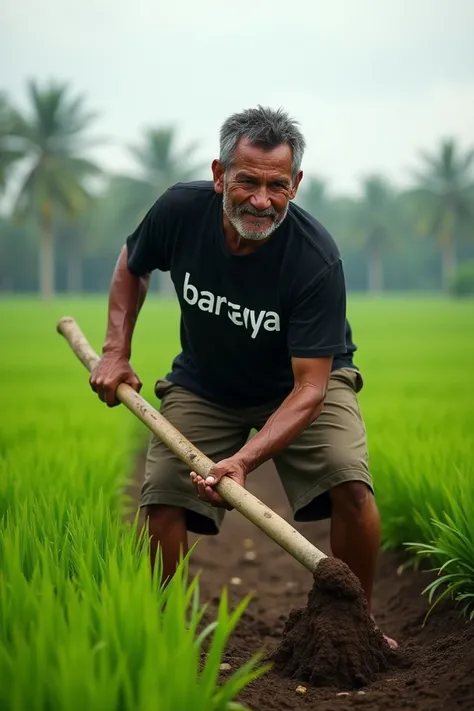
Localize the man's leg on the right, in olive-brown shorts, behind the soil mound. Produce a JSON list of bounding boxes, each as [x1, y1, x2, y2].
[[268, 369, 394, 644]]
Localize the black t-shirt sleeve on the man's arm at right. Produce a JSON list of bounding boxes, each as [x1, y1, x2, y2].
[[288, 259, 346, 358]]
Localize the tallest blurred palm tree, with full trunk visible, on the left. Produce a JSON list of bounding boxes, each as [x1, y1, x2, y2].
[[8, 81, 100, 300]]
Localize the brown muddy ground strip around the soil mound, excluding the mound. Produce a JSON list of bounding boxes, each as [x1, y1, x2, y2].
[[131, 460, 474, 711]]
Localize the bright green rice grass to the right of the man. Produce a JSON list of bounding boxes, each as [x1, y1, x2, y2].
[[351, 299, 474, 615]]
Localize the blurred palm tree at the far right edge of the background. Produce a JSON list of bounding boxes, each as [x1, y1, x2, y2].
[[409, 139, 474, 289]]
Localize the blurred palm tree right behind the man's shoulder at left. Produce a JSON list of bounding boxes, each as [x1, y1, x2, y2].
[[111, 126, 203, 293]]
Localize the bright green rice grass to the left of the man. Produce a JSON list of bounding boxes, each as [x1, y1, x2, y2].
[[0, 301, 267, 711]]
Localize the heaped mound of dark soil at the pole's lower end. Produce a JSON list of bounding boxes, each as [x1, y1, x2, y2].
[[268, 558, 401, 689]]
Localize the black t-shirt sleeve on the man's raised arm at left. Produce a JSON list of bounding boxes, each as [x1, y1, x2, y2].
[[126, 191, 173, 276]]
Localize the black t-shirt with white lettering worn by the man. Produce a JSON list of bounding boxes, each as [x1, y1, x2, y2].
[[127, 181, 355, 407]]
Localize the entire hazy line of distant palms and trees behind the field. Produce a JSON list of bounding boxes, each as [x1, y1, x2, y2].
[[0, 80, 474, 300]]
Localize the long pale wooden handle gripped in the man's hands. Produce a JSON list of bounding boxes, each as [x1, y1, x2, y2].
[[57, 316, 326, 573]]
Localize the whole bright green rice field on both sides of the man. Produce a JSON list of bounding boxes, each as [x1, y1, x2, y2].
[[0, 296, 474, 711]]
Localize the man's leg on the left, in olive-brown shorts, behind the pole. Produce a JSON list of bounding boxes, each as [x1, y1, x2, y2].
[[140, 380, 249, 582]]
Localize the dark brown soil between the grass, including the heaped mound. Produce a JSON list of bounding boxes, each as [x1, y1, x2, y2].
[[132, 462, 474, 711]]
